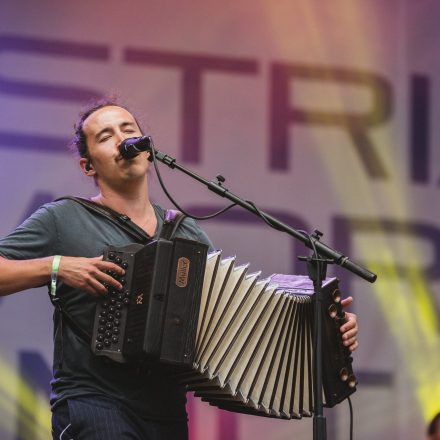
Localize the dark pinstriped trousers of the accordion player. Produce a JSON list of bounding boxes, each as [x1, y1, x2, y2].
[[52, 397, 188, 440]]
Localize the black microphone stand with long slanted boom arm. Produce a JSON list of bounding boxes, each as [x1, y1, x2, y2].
[[148, 141, 377, 440]]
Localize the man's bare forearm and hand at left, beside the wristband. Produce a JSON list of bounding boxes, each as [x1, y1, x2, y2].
[[0, 256, 125, 296]]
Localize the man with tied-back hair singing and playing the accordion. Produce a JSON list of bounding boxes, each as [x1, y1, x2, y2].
[[0, 102, 358, 440]]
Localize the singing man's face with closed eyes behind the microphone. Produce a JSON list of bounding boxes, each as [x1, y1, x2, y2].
[[80, 106, 148, 188]]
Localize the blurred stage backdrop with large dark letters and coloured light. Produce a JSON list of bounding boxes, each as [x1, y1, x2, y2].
[[0, 0, 440, 440]]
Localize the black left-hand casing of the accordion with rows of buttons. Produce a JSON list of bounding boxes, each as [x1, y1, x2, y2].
[[91, 238, 208, 368]]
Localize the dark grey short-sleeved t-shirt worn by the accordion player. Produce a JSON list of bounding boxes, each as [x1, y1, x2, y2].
[[0, 200, 213, 420]]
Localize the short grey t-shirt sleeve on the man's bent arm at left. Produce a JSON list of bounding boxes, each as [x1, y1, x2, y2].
[[0, 206, 58, 260]]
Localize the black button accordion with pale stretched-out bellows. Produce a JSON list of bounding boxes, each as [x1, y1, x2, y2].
[[92, 238, 356, 419]]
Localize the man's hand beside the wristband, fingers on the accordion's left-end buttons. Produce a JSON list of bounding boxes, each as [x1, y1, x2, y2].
[[58, 256, 125, 296]]
